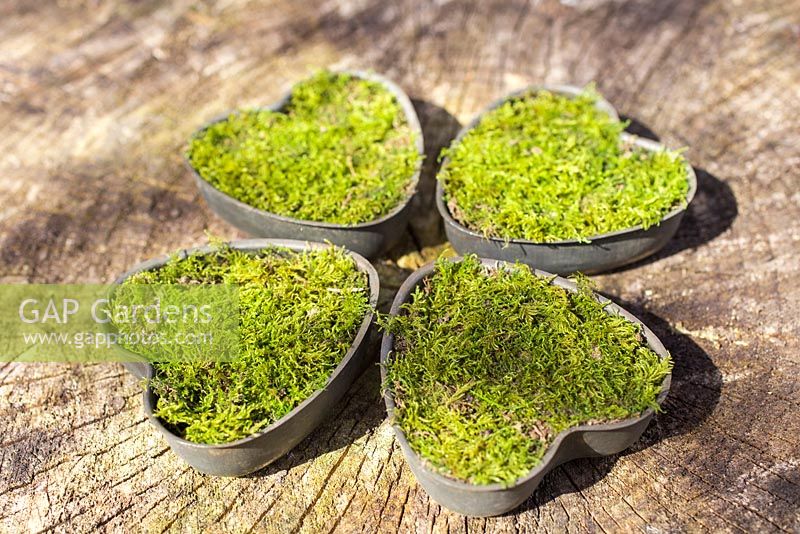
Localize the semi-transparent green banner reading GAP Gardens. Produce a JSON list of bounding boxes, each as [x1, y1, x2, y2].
[[0, 284, 239, 363]]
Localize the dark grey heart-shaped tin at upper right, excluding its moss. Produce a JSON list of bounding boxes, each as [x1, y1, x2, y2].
[[436, 85, 697, 275]]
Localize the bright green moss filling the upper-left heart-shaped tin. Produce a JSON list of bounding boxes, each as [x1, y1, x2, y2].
[[187, 72, 420, 225]]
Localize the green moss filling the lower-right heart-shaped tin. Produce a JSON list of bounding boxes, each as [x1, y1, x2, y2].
[[381, 256, 671, 484]]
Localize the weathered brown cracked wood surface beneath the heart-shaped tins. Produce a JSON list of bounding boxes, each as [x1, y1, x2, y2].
[[0, 0, 800, 532]]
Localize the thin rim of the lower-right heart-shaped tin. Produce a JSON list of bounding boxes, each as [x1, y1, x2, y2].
[[380, 256, 672, 493]]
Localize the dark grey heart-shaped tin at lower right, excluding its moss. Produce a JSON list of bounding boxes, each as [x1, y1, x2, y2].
[[381, 258, 672, 517]]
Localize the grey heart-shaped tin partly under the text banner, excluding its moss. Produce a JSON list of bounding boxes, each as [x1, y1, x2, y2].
[[115, 239, 379, 476]]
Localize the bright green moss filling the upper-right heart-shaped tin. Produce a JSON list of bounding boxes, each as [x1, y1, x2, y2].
[[439, 89, 689, 242]]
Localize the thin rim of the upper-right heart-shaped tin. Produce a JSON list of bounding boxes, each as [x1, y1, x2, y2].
[[436, 84, 697, 246]]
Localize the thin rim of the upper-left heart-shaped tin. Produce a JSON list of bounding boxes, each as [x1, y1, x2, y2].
[[183, 70, 425, 230]]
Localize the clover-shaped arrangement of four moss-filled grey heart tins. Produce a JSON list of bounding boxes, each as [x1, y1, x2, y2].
[[118, 71, 696, 516]]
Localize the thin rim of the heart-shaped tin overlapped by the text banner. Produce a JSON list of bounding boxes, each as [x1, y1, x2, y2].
[[114, 238, 380, 450]]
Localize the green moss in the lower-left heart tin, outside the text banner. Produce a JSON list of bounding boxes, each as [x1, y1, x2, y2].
[[126, 247, 370, 443]]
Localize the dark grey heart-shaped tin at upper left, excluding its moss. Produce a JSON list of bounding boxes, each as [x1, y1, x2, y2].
[[185, 71, 425, 258]]
